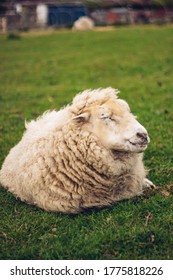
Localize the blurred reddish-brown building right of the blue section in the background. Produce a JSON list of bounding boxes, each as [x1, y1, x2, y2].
[[90, 0, 173, 25]]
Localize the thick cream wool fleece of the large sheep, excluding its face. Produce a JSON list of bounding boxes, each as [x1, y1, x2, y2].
[[0, 88, 145, 213]]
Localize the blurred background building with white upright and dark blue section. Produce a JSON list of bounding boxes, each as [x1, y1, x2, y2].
[[0, 0, 87, 32]]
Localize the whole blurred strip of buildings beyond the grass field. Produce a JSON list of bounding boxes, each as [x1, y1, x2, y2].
[[0, 0, 173, 33]]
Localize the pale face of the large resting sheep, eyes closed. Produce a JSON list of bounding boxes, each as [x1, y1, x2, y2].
[[75, 99, 150, 153]]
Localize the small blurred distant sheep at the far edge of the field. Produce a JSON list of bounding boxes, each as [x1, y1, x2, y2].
[[72, 16, 94, 31]]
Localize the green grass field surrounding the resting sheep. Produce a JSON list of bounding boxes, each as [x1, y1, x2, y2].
[[0, 26, 173, 259]]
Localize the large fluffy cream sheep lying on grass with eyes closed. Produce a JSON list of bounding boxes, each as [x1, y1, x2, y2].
[[0, 88, 153, 213]]
